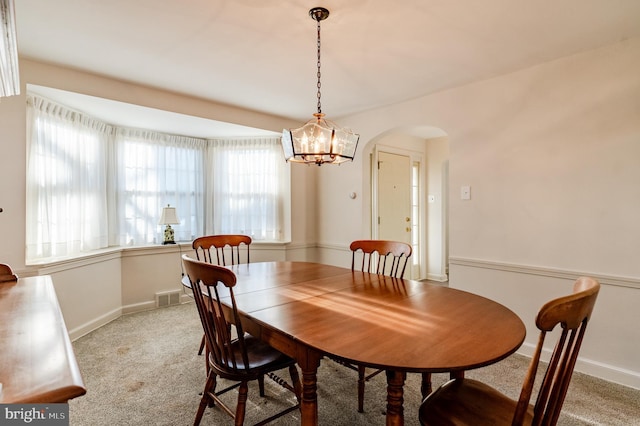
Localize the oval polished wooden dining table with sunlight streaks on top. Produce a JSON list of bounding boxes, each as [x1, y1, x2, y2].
[[190, 262, 525, 425]]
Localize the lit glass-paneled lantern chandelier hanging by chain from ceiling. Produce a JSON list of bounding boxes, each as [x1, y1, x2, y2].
[[282, 7, 360, 166]]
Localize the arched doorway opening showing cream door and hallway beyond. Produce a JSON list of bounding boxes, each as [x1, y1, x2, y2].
[[362, 126, 449, 281]]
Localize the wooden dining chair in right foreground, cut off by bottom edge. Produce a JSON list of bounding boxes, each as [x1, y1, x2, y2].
[[419, 277, 600, 426]]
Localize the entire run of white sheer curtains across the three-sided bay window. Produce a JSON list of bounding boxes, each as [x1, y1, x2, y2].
[[26, 93, 289, 262]]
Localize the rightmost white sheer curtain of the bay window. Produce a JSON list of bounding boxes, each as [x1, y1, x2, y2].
[[205, 138, 287, 241]]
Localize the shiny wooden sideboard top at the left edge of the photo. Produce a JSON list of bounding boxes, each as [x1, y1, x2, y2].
[[0, 276, 86, 404]]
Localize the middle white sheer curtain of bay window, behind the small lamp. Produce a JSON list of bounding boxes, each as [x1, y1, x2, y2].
[[116, 129, 207, 245]]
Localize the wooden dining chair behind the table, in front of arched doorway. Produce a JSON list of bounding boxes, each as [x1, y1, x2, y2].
[[331, 240, 420, 413]]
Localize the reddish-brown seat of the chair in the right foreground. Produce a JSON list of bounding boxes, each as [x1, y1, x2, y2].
[[419, 379, 533, 426]]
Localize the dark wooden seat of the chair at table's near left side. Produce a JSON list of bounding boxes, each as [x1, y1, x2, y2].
[[209, 334, 295, 379]]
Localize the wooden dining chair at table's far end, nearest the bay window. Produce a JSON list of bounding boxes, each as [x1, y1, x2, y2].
[[191, 234, 252, 355]]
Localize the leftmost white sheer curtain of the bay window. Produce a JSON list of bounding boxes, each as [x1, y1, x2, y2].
[[26, 96, 113, 259]]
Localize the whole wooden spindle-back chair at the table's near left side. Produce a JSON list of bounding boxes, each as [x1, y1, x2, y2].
[[182, 255, 302, 425]]
